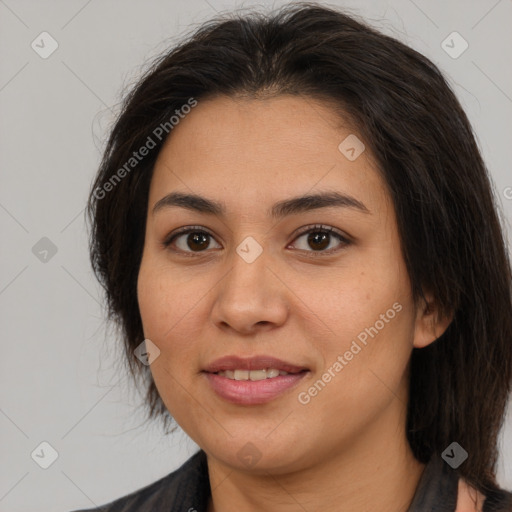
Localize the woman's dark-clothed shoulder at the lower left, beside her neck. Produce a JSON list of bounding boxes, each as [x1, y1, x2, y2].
[[68, 450, 210, 512]]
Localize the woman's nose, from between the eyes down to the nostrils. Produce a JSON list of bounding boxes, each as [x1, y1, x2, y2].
[[212, 240, 289, 334]]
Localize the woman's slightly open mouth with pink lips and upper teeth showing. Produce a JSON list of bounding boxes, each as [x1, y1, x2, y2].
[[203, 356, 310, 405]]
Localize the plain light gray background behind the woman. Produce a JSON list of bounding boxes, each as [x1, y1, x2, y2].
[[0, 0, 512, 512]]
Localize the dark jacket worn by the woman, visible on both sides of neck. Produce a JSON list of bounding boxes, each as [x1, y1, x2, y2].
[[71, 450, 512, 512]]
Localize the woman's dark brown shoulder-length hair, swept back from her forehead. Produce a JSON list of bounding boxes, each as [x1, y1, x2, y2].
[[87, 3, 512, 493]]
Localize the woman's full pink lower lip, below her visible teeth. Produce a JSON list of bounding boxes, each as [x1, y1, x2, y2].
[[205, 372, 309, 405]]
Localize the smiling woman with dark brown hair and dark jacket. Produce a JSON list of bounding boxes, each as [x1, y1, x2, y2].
[[74, 4, 512, 512]]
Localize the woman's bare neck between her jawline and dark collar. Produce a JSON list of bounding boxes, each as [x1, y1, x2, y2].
[[208, 400, 425, 512]]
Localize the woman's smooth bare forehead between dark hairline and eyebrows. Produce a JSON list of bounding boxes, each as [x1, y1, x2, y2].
[[150, 95, 386, 214]]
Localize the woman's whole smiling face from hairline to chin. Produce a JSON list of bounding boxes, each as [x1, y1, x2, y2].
[[138, 96, 432, 472]]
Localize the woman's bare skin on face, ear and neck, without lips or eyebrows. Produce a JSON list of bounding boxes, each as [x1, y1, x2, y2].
[[138, 96, 468, 512]]
